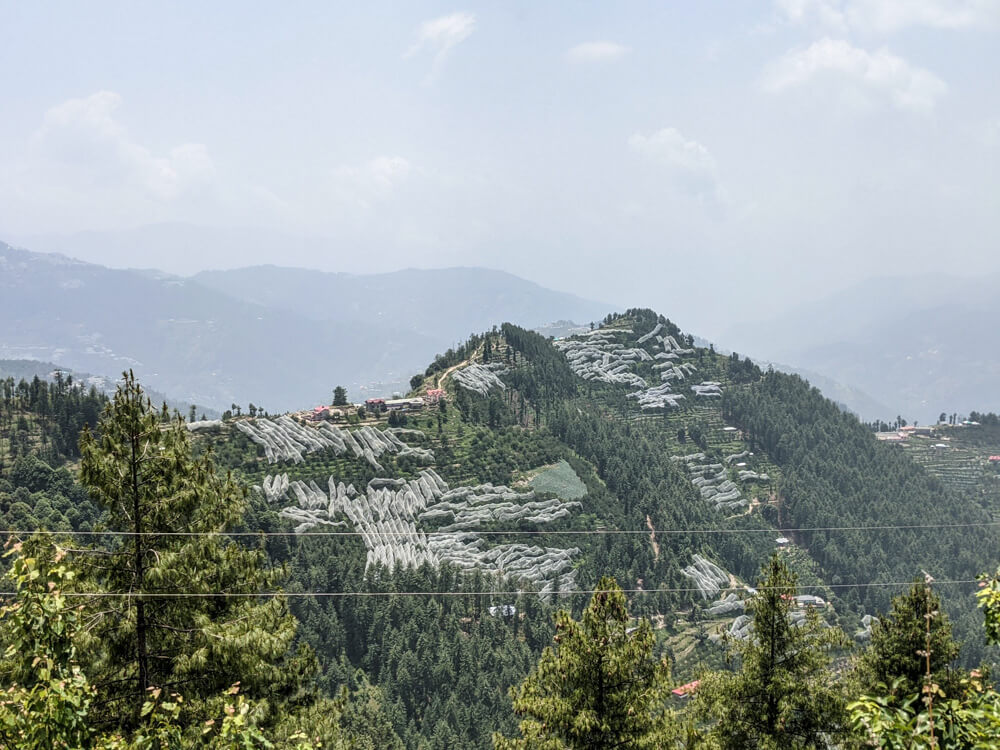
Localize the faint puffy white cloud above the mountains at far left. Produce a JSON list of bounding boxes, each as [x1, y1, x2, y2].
[[31, 91, 215, 201]]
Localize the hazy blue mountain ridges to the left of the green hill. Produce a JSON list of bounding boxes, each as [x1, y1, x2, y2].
[[0, 243, 613, 411]]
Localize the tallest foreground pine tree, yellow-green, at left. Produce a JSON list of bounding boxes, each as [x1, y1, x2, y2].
[[80, 372, 314, 725]]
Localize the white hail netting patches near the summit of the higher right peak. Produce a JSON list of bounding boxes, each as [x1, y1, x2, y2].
[[554, 323, 696, 409]]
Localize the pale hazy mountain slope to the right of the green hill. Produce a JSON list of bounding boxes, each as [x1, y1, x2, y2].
[[720, 275, 1000, 424]]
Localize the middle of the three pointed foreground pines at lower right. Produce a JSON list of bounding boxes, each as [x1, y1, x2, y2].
[[696, 555, 846, 750]]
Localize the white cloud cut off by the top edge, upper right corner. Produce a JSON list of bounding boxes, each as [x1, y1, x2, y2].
[[776, 0, 1000, 32]]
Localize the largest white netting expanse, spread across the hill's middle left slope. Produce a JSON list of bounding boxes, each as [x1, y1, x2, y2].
[[263, 469, 582, 592]]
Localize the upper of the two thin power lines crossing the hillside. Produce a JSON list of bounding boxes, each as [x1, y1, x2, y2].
[[0, 521, 1000, 537]]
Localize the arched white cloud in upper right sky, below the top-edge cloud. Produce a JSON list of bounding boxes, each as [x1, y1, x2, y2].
[[762, 39, 948, 112]]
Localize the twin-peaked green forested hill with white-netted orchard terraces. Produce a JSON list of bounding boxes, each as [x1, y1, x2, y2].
[[0, 310, 1000, 748]]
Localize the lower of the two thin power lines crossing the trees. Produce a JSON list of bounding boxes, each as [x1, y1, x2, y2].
[[0, 578, 981, 600]]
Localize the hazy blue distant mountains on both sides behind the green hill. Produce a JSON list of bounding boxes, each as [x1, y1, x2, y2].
[[0, 234, 1000, 423]]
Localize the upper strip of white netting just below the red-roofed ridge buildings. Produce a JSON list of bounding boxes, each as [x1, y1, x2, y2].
[[235, 414, 434, 471]]
